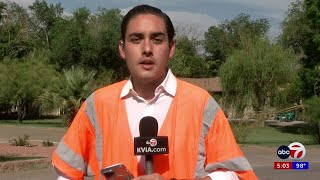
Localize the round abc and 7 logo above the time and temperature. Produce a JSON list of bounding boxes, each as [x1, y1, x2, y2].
[[277, 142, 306, 160]]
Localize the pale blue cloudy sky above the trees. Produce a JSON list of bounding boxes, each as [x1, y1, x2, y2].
[[0, 0, 295, 38]]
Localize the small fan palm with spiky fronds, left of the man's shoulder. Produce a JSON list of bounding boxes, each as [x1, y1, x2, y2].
[[37, 66, 96, 126]]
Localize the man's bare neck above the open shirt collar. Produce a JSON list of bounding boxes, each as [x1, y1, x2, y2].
[[131, 71, 167, 101]]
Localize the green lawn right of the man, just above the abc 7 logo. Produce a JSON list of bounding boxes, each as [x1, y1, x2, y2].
[[243, 125, 317, 146]]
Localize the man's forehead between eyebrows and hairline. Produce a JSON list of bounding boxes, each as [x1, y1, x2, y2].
[[126, 14, 167, 36]]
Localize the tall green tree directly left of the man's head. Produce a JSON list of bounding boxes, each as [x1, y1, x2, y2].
[[87, 8, 129, 81]]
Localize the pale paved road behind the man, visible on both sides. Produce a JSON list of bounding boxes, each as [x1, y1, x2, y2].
[[0, 125, 320, 180]]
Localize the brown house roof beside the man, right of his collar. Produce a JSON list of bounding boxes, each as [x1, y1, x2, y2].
[[179, 77, 222, 92]]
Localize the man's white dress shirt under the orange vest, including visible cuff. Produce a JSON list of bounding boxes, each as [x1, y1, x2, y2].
[[58, 69, 238, 180]]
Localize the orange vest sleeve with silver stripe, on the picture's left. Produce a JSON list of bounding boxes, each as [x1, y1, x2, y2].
[[52, 101, 101, 179]]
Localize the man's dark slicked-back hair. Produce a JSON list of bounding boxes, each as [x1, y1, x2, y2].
[[121, 4, 174, 42]]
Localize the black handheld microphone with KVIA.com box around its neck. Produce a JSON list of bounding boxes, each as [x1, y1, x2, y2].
[[134, 116, 169, 174]]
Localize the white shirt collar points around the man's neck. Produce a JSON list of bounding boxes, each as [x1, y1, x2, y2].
[[120, 69, 177, 98]]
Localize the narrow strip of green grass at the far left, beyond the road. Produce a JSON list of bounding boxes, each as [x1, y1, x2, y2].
[[0, 118, 65, 127]]
